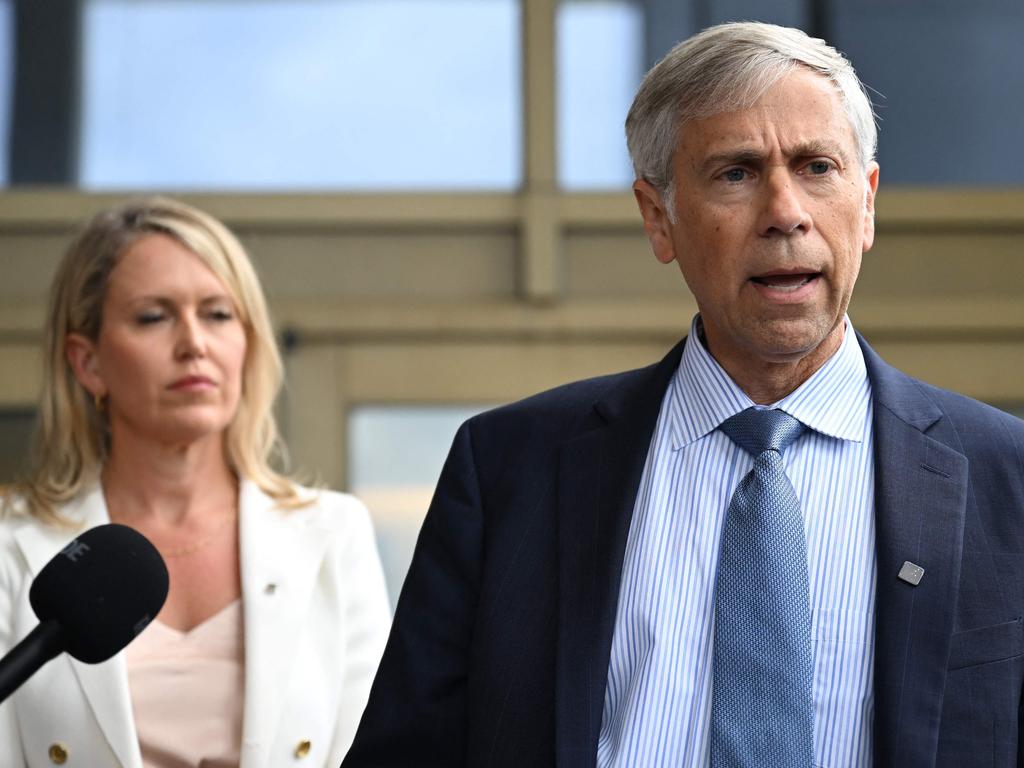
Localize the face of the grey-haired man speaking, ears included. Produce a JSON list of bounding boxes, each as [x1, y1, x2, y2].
[[635, 69, 878, 375]]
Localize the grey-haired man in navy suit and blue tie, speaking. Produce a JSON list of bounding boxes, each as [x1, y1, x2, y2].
[[344, 24, 1024, 768]]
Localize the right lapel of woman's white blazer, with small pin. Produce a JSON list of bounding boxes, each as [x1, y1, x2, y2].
[[240, 481, 327, 768]]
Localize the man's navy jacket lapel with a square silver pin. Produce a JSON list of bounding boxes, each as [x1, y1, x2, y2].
[[860, 339, 968, 766]]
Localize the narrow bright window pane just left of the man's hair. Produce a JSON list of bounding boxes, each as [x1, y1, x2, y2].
[[556, 0, 643, 189]]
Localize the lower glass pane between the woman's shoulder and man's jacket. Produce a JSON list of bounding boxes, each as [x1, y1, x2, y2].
[[348, 406, 490, 606]]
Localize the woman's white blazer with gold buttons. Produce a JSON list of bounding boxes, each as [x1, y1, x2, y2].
[[0, 481, 390, 768]]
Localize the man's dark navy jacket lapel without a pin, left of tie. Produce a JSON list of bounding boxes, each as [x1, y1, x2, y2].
[[555, 342, 684, 768]]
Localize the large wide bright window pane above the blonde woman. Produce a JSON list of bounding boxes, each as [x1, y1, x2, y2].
[[81, 0, 521, 189]]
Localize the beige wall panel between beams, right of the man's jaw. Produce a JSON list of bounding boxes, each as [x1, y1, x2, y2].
[[857, 229, 1024, 297]]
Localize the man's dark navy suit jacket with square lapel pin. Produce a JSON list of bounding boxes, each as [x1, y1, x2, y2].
[[344, 339, 1024, 768]]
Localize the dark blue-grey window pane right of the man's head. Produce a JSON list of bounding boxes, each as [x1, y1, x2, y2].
[[831, 0, 1024, 185]]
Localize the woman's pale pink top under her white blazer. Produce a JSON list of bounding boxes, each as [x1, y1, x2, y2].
[[125, 600, 245, 768]]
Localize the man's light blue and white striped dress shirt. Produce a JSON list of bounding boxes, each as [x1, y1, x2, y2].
[[597, 318, 876, 768]]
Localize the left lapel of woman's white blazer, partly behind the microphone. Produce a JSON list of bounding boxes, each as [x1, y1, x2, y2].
[[14, 484, 142, 768]]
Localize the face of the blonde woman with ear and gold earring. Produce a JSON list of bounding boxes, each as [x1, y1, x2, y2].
[[68, 234, 246, 444]]
